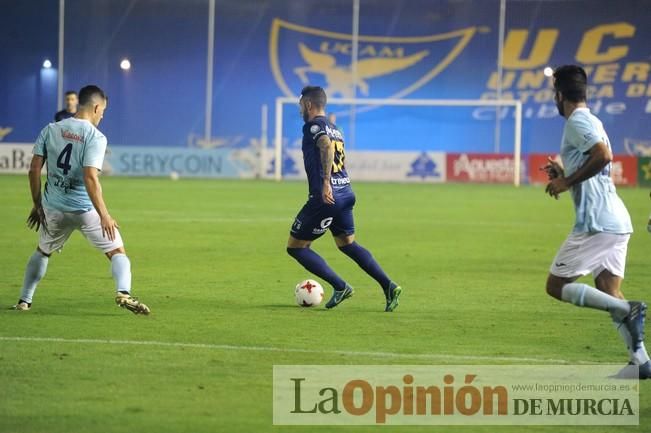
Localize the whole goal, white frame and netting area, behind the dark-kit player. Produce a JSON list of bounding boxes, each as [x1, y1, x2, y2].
[[269, 97, 522, 186]]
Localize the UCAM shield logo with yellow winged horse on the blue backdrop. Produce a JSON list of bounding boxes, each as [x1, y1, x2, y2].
[[269, 19, 485, 98]]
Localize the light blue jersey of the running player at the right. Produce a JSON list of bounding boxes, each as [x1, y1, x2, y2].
[[561, 108, 633, 234]]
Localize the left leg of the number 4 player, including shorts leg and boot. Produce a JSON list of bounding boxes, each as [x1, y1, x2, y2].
[[15, 209, 74, 311]]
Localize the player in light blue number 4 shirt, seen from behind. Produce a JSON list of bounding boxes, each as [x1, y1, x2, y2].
[[14, 85, 149, 314]]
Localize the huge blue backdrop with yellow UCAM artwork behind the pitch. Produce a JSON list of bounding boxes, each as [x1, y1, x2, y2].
[[0, 0, 651, 179]]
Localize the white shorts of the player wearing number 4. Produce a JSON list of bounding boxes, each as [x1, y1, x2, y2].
[[38, 208, 124, 254]]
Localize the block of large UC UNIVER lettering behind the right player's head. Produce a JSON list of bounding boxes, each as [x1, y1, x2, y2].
[[473, 21, 651, 122]]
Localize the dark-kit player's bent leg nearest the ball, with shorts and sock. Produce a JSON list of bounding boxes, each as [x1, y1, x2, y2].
[[287, 200, 353, 306]]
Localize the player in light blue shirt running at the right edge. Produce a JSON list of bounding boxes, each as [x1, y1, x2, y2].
[[544, 65, 651, 379]]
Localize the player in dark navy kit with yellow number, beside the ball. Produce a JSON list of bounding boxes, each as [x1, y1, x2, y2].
[[287, 86, 402, 312]]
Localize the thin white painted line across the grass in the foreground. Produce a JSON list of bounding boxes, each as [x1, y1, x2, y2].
[[0, 336, 593, 364]]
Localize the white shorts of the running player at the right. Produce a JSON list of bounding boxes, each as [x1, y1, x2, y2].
[[549, 233, 631, 278]]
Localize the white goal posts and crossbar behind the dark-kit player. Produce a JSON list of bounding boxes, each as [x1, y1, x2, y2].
[[274, 97, 522, 186]]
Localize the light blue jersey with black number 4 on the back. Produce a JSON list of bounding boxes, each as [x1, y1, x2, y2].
[[33, 117, 107, 212]]
